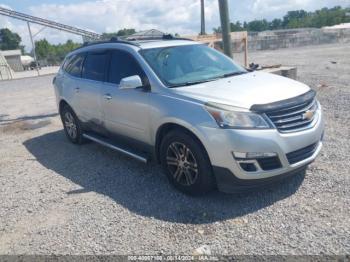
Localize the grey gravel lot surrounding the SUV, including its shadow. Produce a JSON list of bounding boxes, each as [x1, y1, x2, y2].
[[0, 42, 350, 254]]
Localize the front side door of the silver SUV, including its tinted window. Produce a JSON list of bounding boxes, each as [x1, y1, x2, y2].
[[102, 49, 150, 143]]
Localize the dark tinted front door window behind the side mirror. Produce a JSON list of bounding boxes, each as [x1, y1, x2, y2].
[[108, 50, 147, 84]]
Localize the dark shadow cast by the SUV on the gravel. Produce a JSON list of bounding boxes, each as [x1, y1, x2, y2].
[[24, 130, 305, 224]]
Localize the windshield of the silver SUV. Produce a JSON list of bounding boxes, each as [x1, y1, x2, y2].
[[140, 45, 247, 87]]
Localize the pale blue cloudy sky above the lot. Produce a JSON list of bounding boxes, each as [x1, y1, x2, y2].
[[0, 0, 350, 49]]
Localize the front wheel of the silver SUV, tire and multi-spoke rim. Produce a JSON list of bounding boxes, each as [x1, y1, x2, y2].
[[160, 130, 216, 196]]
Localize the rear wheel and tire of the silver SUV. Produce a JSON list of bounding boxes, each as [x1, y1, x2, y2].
[[61, 105, 85, 144]]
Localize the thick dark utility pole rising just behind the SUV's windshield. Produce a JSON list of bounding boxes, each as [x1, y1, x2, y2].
[[218, 0, 232, 57]]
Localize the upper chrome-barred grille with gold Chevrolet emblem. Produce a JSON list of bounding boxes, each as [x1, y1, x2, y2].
[[266, 99, 317, 133]]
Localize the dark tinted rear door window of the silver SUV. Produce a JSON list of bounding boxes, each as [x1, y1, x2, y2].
[[82, 52, 108, 81]]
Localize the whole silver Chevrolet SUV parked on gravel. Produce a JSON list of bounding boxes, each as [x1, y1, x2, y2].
[[54, 38, 324, 195]]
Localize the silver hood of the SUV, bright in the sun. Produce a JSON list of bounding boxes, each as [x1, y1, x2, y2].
[[173, 72, 310, 109]]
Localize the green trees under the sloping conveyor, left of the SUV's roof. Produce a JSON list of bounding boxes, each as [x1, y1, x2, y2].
[[35, 39, 81, 65]]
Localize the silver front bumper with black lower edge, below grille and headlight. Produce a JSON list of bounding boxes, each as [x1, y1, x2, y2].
[[198, 107, 324, 192]]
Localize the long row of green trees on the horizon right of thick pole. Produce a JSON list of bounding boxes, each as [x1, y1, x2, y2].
[[213, 6, 350, 33]]
